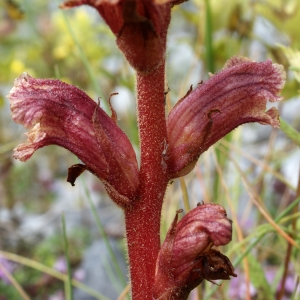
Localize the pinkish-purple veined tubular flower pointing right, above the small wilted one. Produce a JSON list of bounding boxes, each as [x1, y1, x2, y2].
[[167, 57, 285, 178]]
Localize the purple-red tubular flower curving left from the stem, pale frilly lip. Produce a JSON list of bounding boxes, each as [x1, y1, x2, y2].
[[8, 73, 139, 206]]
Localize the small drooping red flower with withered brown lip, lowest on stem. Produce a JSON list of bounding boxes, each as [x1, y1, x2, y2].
[[153, 204, 236, 300]]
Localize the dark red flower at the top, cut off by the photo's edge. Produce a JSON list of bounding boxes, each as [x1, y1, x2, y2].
[[61, 0, 183, 73]]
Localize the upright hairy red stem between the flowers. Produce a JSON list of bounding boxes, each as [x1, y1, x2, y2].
[[125, 64, 168, 300]]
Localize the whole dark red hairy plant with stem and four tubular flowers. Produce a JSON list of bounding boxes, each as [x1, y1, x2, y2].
[[9, 0, 285, 300]]
